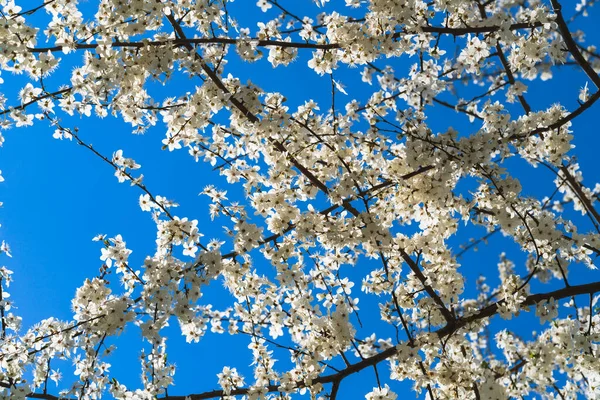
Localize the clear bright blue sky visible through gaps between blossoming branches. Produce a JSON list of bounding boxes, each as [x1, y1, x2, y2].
[[0, 0, 600, 398]]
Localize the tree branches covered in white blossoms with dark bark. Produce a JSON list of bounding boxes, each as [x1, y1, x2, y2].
[[0, 0, 600, 400]]
